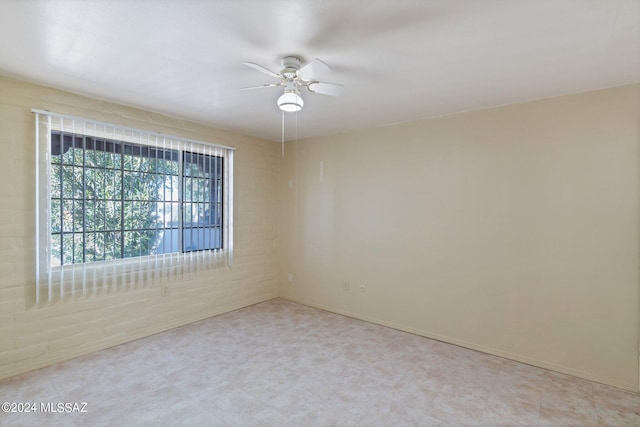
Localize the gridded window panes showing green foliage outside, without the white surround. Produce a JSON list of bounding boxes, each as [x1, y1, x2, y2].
[[49, 132, 224, 265]]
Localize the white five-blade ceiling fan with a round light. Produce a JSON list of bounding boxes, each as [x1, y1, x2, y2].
[[241, 56, 343, 112]]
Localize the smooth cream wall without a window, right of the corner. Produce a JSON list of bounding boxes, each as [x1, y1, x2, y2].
[[280, 85, 640, 391]]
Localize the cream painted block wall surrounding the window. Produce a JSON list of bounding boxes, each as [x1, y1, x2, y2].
[[0, 78, 281, 378]]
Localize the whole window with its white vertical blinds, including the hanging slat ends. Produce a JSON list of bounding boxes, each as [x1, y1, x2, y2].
[[32, 109, 234, 303]]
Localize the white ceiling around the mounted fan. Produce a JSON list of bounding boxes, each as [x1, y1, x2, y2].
[[0, 0, 640, 140]]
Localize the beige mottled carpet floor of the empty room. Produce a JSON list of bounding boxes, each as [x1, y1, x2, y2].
[[0, 299, 640, 427]]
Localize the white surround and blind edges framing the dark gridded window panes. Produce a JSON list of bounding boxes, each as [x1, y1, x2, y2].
[[32, 109, 235, 300]]
